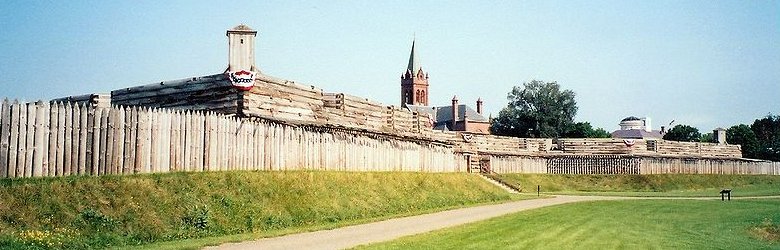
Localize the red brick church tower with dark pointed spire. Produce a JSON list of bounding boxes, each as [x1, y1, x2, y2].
[[401, 40, 428, 107]]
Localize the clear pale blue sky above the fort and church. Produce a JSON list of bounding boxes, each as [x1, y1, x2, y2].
[[0, 1, 780, 132]]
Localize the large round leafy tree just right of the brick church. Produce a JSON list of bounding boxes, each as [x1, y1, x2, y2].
[[490, 80, 577, 138]]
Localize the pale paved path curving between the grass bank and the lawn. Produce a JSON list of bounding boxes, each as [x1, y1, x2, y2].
[[206, 195, 780, 250]]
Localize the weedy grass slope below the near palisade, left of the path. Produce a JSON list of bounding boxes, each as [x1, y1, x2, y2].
[[0, 172, 512, 249]]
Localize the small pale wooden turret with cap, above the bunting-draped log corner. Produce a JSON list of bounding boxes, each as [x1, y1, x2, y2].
[[226, 24, 259, 72]]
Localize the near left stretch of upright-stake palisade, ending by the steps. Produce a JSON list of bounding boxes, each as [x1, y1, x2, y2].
[[0, 100, 466, 178]]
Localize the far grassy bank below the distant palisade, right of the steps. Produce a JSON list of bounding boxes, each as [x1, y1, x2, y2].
[[500, 174, 780, 197]]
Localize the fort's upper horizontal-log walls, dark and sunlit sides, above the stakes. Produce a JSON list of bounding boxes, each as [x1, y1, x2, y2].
[[94, 74, 741, 158]]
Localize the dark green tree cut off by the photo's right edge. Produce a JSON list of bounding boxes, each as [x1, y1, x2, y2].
[[750, 114, 780, 161]]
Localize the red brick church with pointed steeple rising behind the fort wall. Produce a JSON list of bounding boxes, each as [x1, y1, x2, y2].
[[401, 41, 490, 134]]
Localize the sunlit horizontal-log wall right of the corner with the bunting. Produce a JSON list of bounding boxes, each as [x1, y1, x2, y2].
[[238, 75, 430, 133]]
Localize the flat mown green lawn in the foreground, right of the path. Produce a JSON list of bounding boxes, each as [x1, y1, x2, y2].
[[358, 199, 780, 249]]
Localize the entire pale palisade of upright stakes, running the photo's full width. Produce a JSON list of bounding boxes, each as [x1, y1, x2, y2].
[[0, 100, 780, 178]]
